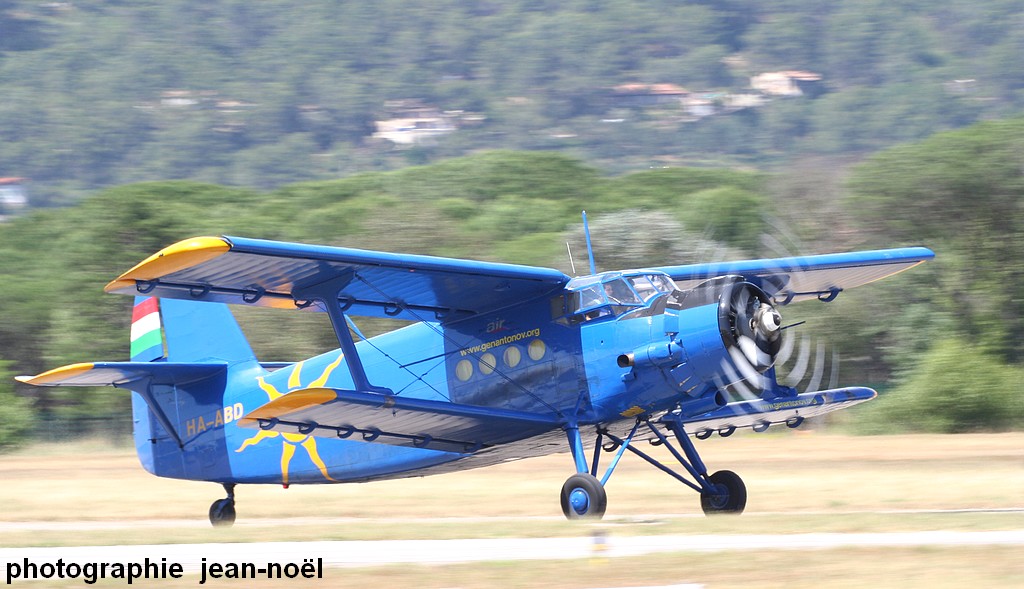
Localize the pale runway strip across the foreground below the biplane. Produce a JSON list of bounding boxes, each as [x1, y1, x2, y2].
[[0, 530, 1024, 574]]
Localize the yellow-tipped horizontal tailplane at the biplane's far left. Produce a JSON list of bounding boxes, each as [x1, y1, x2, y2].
[[16, 362, 227, 388]]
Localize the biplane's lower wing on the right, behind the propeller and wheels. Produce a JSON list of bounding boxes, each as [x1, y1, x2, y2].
[[662, 387, 878, 433]]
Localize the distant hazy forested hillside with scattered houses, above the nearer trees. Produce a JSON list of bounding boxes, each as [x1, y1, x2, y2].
[[0, 0, 1024, 206]]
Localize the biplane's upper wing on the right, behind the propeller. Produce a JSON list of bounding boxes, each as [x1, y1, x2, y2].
[[655, 248, 935, 303]]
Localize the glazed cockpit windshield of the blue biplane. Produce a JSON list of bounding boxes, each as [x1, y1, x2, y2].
[[566, 272, 676, 320]]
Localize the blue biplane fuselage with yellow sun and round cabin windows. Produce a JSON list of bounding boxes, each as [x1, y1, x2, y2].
[[136, 271, 745, 483]]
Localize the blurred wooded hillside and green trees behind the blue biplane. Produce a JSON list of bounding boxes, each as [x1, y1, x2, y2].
[[0, 0, 1024, 449]]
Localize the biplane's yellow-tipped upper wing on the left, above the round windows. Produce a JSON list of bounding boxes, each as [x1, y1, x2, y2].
[[106, 237, 569, 321]]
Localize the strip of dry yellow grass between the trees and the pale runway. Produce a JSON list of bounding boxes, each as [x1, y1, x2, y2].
[[0, 432, 1024, 521]]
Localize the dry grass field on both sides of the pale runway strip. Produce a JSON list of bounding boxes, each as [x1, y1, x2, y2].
[[0, 431, 1024, 588]]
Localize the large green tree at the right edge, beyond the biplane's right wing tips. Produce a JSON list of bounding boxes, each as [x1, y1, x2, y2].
[[850, 119, 1024, 363]]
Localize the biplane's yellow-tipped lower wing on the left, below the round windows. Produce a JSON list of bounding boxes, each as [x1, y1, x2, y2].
[[239, 388, 561, 454]]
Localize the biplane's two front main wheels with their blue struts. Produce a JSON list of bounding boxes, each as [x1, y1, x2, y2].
[[561, 415, 746, 519]]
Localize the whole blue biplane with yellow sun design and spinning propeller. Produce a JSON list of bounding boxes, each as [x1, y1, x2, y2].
[[19, 232, 934, 525]]
